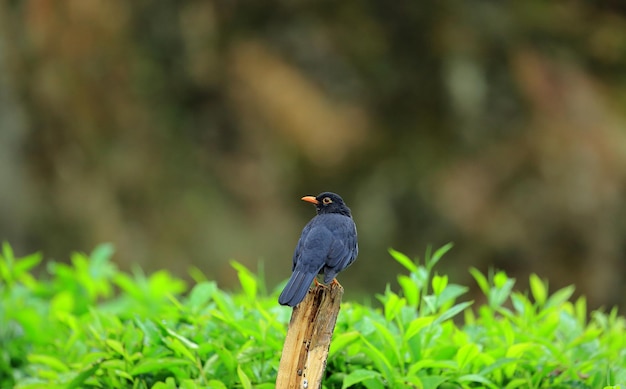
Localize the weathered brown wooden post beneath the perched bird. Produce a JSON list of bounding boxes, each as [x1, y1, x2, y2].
[[276, 282, 343, 389]]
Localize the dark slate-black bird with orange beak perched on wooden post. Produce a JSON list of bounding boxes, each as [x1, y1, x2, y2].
[[278, 192, 359, 307]]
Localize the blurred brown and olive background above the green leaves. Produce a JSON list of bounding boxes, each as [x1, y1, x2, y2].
[[0, 0, 626, 308]]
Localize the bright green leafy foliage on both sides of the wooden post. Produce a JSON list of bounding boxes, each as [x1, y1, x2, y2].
[[0, 244, 626, 389]]
